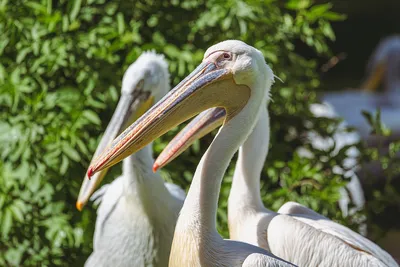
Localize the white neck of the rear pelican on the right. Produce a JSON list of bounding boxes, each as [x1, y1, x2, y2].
[[228, 107, 270, 211]]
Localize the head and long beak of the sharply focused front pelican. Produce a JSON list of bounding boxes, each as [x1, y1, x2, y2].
[[89, 40, 273, 174]]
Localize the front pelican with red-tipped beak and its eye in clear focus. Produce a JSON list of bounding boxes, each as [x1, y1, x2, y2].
[[89, 40, 293, 267]]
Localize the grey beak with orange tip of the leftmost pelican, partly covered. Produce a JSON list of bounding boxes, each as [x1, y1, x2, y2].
[[76, 87, 154, 211]]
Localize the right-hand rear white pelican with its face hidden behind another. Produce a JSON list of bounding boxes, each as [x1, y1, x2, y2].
[[146, 47, 397, 266]]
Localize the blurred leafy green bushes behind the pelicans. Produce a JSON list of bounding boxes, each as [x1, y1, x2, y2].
[[0, 0, 400, 266]]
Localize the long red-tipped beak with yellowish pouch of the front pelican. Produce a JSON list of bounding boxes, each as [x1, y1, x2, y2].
[[88, 58, 250, 176]]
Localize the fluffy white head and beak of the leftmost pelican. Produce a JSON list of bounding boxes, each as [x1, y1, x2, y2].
[[76, 52, 169, 210]]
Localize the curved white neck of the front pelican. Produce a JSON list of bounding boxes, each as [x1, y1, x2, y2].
[[180, 83, 267, 236]]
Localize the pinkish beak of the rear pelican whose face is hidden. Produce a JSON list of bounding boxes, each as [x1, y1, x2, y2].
[[153, 108, 226, 172]]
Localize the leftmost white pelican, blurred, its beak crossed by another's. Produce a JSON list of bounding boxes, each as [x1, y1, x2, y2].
[[77, 52, 185, 267]]
